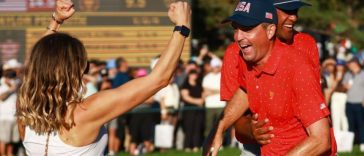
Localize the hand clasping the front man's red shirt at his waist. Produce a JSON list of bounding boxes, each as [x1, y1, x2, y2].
[[251, 114, 274, 145]]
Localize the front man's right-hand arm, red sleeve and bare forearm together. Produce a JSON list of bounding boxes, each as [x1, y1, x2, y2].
[[288, 63, 332, 155]]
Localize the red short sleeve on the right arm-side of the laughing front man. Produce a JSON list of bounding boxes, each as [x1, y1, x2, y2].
[[292, 63, 330, 127]]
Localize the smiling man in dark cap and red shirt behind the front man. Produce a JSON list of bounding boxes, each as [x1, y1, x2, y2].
[[221, 0, 320, 105]]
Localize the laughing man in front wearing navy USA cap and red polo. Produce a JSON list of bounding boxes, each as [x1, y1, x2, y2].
[[205, 1, 336, 155]]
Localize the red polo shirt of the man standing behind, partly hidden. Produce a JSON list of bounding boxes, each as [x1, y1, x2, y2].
[[220, 32, 320, 101]]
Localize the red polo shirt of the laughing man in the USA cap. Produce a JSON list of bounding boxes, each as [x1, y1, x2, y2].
[[241, 42, 330, 155]]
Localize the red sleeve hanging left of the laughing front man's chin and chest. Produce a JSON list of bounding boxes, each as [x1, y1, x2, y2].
[[220, 43, 245, 101]]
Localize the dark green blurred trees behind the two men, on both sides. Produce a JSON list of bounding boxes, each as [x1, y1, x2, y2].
[[192, 0, 364, 54]]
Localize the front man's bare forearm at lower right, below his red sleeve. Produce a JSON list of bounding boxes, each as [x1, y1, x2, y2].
[[287, 118, 331, 156]]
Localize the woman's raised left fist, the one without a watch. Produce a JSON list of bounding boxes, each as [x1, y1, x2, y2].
[[54, 0, 75, 21]]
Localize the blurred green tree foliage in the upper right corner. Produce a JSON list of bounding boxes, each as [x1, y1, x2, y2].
[[299, 0, 364, 48]]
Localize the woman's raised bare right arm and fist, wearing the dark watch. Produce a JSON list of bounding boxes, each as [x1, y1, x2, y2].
[[75, 2, 191, 127]]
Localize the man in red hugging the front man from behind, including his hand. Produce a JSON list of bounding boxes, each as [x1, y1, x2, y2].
[[230, 0, 324, 147]]
